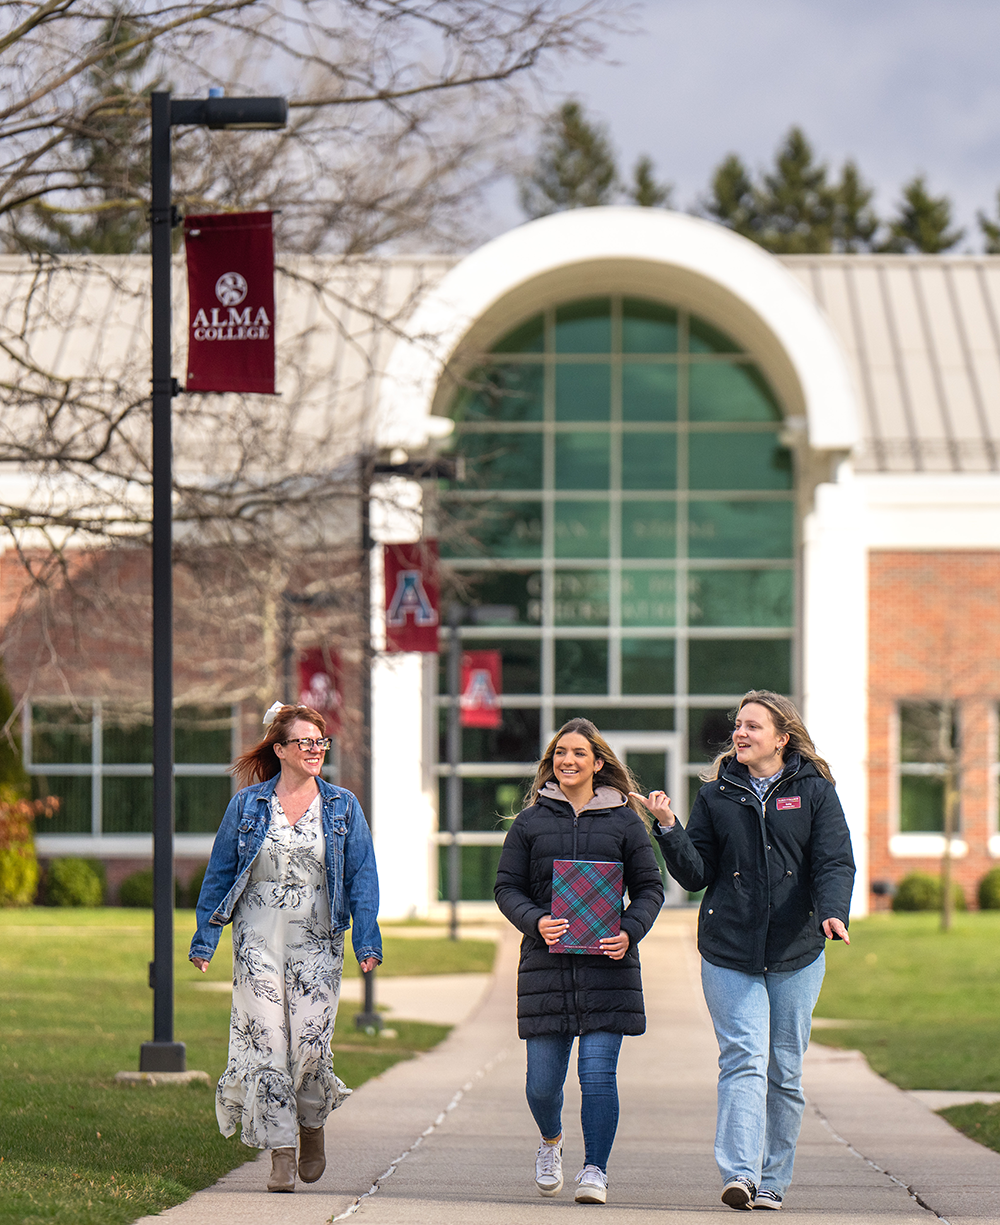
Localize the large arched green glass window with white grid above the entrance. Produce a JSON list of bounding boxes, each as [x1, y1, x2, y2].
[[442, 296, 795, 895]]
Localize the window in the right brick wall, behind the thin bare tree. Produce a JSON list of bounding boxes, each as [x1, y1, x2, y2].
[[898, 702, 958, 834]]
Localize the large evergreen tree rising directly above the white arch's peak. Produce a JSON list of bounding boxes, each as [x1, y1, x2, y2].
[[521, 102, 618, 218]]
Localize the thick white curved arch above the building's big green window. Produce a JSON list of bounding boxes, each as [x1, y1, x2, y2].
[[379, 207, 858, 450]]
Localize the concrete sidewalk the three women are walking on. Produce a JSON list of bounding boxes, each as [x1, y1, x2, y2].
[[143, 911, 1000, 1225]]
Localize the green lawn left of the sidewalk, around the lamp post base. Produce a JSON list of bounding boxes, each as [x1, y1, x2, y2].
[[0, 908, 494, 1225]]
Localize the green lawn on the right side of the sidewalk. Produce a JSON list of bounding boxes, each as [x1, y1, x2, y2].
[[814, 910, 1000, 1152]]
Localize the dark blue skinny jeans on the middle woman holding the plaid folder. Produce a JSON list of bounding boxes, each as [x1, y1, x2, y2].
[[526, 1029, 621, 1174]]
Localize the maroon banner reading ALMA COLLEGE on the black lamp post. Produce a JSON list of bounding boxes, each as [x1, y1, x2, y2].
[[184, 213, 275, 396]]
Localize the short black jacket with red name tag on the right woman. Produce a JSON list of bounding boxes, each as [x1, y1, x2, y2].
[[653, 753, 854, 974]]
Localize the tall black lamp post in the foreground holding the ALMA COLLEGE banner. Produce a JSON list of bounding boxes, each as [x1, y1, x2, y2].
[[138, 91, 288, 1072]]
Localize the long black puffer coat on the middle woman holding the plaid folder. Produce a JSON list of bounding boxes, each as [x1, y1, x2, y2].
[[494, 784, 663, 1038]]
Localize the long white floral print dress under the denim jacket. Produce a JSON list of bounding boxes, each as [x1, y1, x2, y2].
[[216, 795, 350, 1149]]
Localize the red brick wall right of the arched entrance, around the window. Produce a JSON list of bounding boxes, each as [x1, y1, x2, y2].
[[868, 551, 1000, 909]]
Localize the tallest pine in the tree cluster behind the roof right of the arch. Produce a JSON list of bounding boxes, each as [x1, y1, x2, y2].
[[757, 127, 837, 255]]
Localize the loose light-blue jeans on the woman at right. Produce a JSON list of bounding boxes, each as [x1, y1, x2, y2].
[[701, 953, 826, 1196]]
